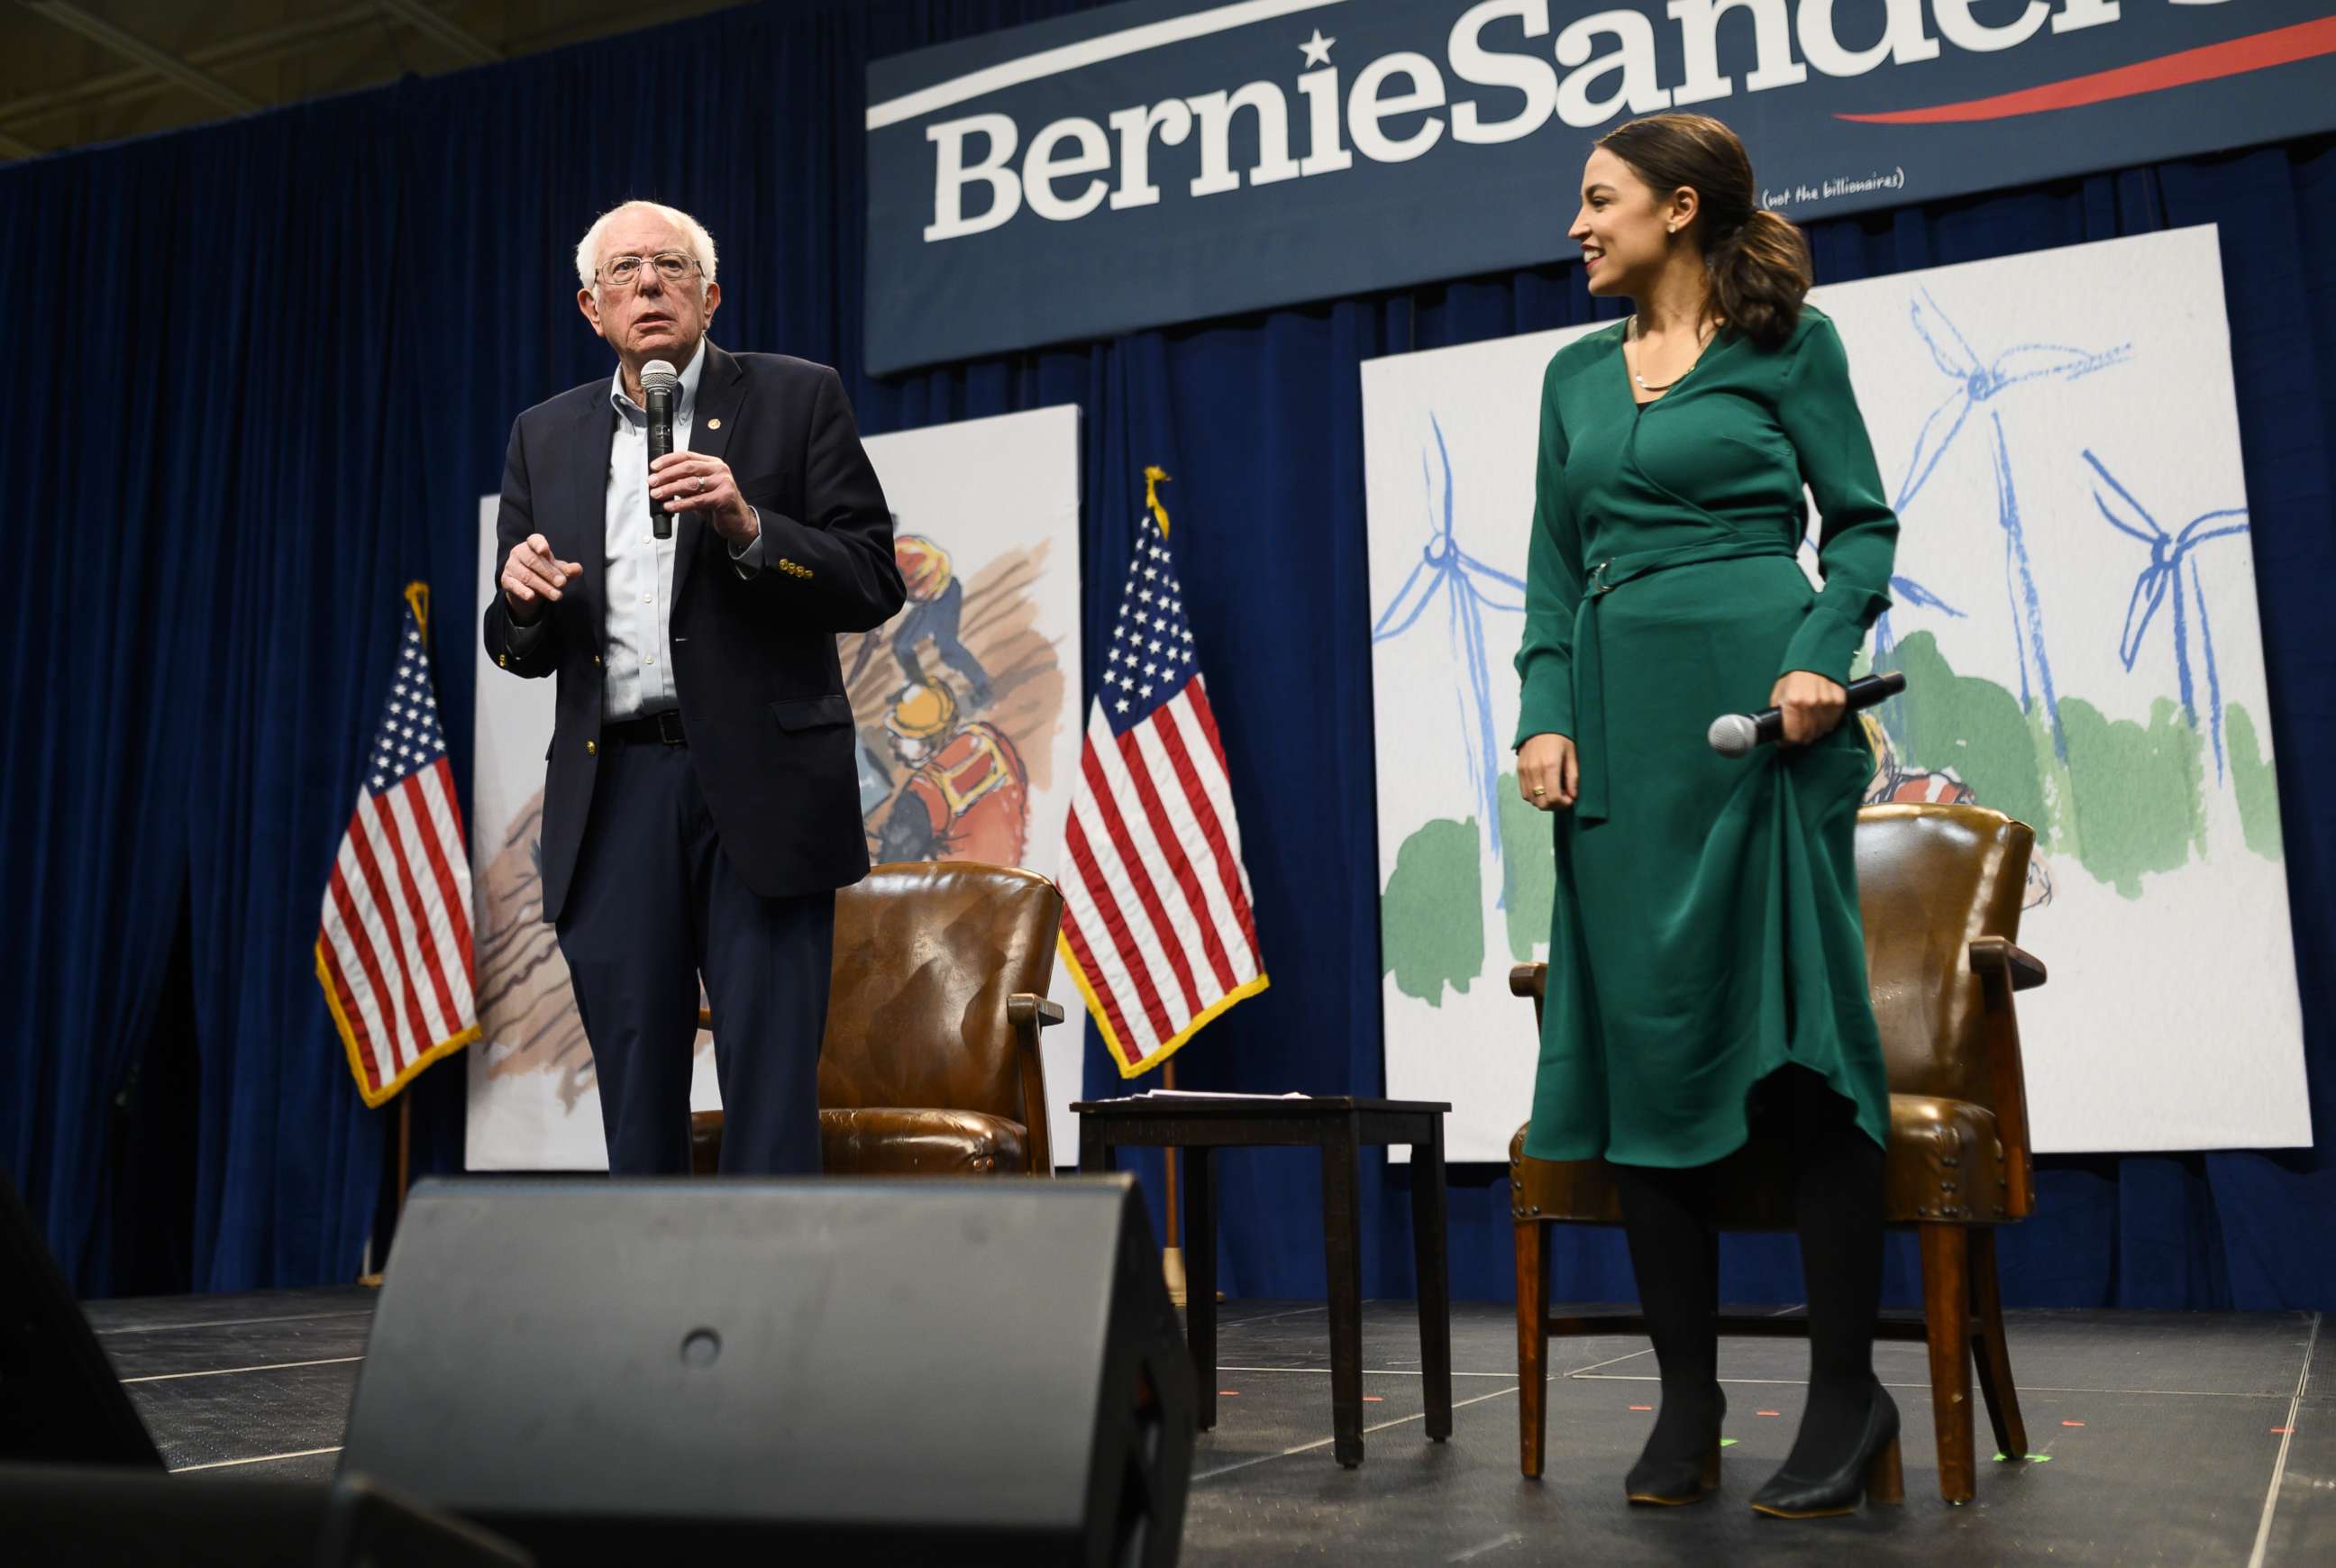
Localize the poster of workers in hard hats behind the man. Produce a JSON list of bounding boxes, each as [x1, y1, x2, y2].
[[467, 406, 1084, 1171]]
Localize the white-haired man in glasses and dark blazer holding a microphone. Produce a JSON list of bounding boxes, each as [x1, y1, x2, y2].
[[486, 201, 904, 1175]]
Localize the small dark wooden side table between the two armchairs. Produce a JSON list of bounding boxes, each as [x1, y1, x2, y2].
[[1072, 1096, 1453, 1470]]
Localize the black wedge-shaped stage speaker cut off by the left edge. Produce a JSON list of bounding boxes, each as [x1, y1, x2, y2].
[[0, 1175, 161, 1470]]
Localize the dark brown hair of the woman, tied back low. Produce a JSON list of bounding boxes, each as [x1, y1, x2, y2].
[[1598, 114, 1811, 348]]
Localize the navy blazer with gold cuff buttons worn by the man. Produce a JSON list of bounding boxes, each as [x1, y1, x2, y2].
[[486, 343, 904, 921]]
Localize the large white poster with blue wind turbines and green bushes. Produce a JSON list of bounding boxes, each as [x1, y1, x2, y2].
[[1362, 229, 2310, 1159]]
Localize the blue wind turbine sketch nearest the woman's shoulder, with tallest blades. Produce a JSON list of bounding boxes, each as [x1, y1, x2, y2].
[[1893, 290, 2132, 761]]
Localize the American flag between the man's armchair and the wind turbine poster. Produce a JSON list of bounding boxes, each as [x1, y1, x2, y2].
[[1061, 469, 1266, 1077]]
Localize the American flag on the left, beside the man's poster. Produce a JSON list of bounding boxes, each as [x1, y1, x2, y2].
[[315, 584, 479, 1106]]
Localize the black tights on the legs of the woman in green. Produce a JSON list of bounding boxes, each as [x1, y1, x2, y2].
[[1614, 1065, 1883, 1470]]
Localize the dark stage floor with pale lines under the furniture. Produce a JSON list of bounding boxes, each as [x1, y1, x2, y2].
[[88, 1288, 2336, 1568]]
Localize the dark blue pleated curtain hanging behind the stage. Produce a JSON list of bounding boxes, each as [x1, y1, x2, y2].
[[0, 0, 2336, 1307]]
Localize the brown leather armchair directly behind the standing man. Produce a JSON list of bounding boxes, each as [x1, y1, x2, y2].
[[691, 860, 1063, 1175]]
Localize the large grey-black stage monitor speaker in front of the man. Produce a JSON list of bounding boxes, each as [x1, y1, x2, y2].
[[341, 1175, 1194, 1568]]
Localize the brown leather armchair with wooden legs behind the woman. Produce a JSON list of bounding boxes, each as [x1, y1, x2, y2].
[[1509, 807, 2044, 1502]]
